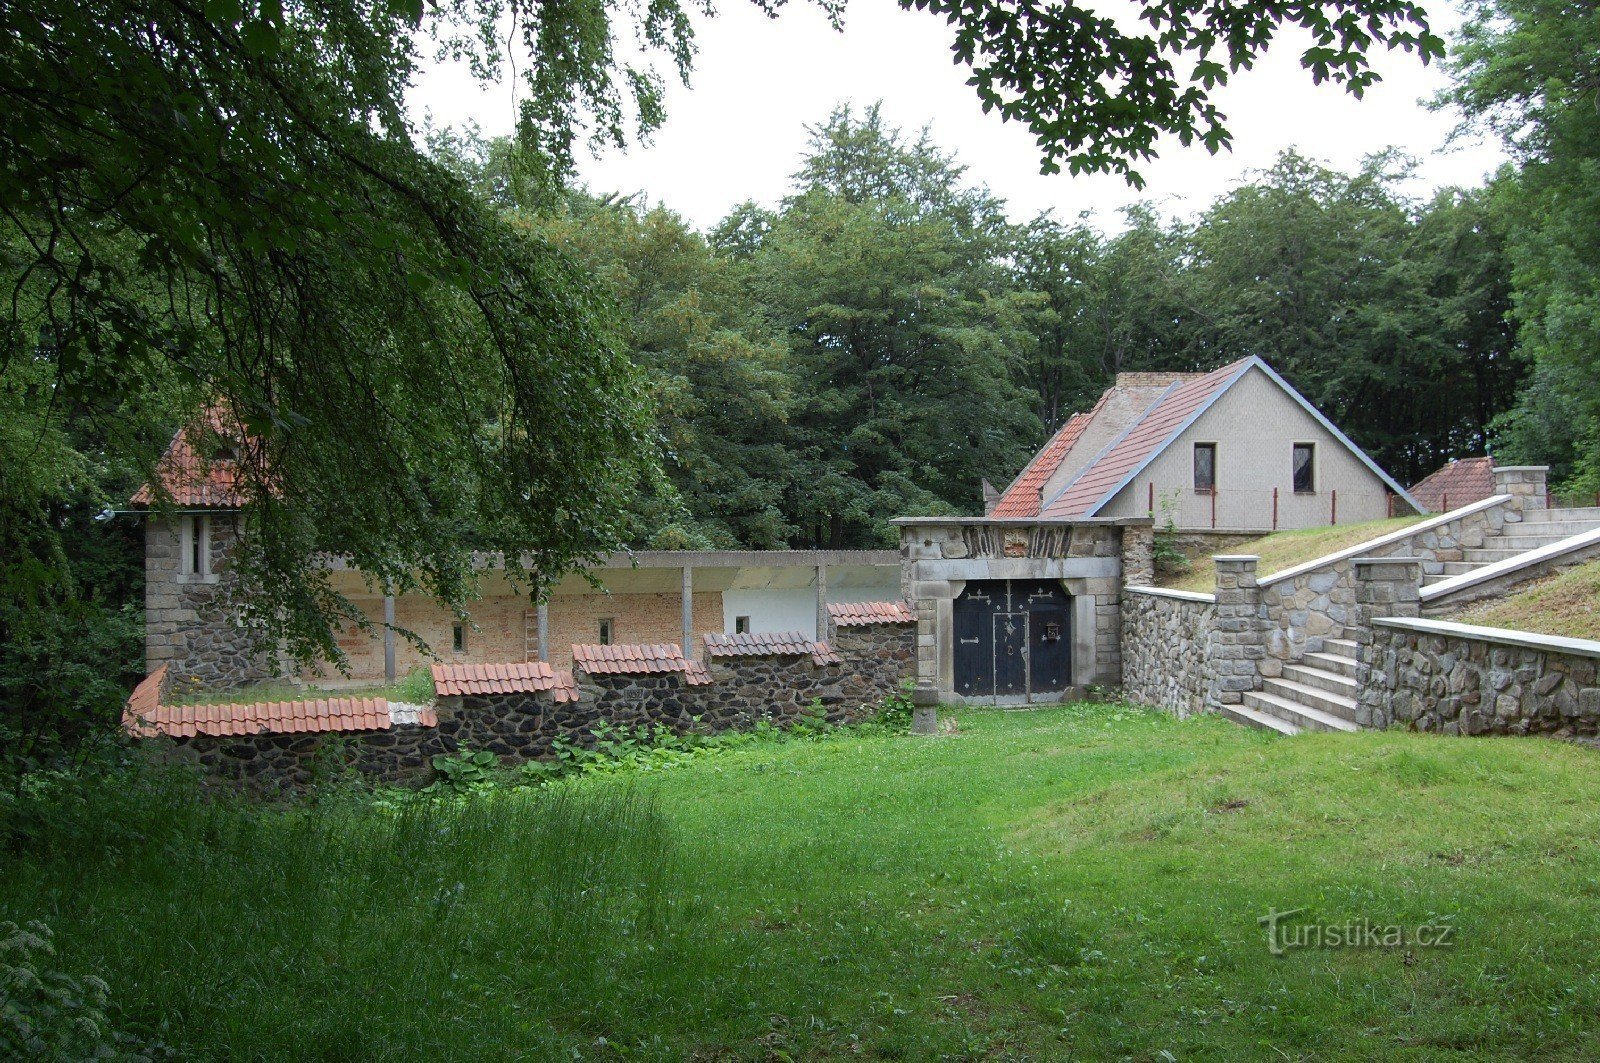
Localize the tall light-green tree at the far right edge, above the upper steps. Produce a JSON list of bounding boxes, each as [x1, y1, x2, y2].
[[1442, 0, 1600, 491]]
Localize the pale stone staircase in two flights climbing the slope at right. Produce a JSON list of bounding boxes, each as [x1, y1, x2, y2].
[[1222, 507, 1600, 735]]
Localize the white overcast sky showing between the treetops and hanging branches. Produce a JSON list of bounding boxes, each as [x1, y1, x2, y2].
[[411, 0, 1502, 229]]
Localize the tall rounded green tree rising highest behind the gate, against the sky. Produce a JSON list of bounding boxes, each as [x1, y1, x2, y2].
[[749, 107, 1038, 548]]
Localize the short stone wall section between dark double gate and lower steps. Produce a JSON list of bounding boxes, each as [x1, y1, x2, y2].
[[1122, 588, 1216, 716]]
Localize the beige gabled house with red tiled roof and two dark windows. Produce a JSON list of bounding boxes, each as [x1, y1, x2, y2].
[[987, 357, 1427, 535]]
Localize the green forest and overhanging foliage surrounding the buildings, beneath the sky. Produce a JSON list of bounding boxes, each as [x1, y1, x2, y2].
[[0, 0, 1600, 742]]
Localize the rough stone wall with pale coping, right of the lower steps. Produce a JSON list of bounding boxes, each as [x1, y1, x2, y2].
[[1358, 618, 1600, 735]]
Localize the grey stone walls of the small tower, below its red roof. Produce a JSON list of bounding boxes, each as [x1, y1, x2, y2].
[[144, 514, 275, 690]]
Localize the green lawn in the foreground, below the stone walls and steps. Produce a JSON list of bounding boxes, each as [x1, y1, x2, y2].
[[0, 706, 1600, 1060]]
